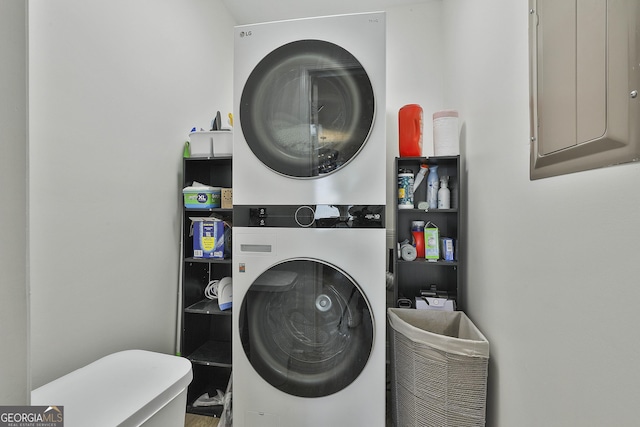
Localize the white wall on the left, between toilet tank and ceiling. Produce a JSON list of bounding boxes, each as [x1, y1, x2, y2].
[[29, 0, 234, 387]]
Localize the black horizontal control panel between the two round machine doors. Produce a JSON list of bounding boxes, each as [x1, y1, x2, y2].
[[233, 205, 385, 228]]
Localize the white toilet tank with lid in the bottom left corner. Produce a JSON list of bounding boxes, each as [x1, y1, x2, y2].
[[31, 350, 193, 427]]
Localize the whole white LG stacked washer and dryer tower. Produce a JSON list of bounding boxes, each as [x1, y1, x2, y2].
[[232, 13, 386, 427]]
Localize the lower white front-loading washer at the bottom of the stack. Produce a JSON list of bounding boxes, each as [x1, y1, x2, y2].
[[232, 206, 386, 427]]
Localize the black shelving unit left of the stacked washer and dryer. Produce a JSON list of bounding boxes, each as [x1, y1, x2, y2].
[[180, 157, 233, 417]]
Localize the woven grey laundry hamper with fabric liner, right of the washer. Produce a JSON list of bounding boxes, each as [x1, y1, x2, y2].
[[387, 308, 489, 427]]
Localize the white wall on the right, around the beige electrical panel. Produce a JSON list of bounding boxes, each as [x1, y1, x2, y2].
[[442, 0, 640, 427]]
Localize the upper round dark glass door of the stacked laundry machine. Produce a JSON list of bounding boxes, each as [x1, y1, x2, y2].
[[240, 40, 375, 178]]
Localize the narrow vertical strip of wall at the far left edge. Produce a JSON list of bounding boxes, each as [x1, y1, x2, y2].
[[0, 0, 30, 405]]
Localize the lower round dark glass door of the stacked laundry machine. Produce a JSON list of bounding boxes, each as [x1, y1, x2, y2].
[[239, 259, 374, 397]]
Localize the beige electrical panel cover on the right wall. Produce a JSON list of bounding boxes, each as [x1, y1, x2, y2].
[[529, 0, 640, 179]]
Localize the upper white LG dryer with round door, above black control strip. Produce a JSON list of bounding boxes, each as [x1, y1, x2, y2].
[[233, 12, 386, 205]]
